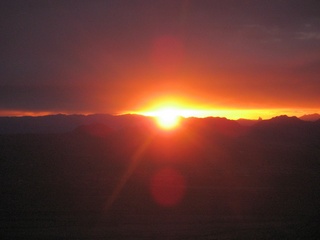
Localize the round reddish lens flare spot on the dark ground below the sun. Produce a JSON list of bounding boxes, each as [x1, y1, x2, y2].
[[150, 168, 186, 207]]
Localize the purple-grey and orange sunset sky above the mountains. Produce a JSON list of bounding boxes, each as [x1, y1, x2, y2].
[[0, 0, 320, 117]]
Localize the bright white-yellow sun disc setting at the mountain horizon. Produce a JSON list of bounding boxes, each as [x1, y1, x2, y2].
[[155, 108, 180, 130]]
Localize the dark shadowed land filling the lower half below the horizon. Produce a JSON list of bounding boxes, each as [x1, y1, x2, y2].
[[0, 117, 320, 239]]
